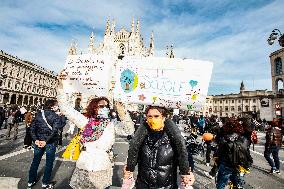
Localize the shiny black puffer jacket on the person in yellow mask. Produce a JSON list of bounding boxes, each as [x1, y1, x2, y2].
[[136, 132, 177, 189]]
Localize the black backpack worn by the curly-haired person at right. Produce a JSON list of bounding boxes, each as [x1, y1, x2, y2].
[[223, 133, 253, 168]]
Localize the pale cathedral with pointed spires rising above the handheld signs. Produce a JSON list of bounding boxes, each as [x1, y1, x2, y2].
[[69, 19, 174, 59]]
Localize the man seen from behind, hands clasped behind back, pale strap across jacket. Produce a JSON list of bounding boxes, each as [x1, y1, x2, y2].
[[28, 100, 66, 189]]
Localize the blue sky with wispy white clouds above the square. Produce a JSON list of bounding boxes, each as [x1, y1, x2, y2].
[[0, 0, 284, 94]]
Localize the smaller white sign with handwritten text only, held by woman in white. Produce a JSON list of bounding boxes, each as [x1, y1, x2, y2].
[[63, 54, 113, 96]]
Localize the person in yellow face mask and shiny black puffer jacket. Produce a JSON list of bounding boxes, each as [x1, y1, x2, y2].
[[124, 106, 194, 189]]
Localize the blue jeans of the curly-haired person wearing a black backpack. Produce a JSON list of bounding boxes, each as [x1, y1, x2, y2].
[[216, 163, 244, 189]]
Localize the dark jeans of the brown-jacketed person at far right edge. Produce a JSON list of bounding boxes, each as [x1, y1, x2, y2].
[[264, 146, 280, 170]]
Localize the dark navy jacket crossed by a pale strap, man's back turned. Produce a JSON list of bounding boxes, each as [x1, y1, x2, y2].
[[31, 110, 66, 144]]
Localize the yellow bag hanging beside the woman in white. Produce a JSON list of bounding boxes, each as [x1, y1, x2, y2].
[[62, 129, 83, 160]]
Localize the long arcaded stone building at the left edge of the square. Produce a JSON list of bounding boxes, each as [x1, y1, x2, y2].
[[0, 50, 58, 106]]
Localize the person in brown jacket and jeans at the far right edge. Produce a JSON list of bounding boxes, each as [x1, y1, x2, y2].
[[264, 122, 282, 174]]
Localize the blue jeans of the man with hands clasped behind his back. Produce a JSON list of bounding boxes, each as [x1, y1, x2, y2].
[[29, 144, 56, 184]]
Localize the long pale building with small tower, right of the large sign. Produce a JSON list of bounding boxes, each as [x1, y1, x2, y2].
[[201, 82, 273, 120]]
